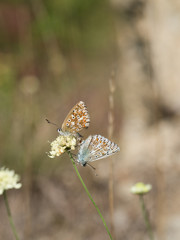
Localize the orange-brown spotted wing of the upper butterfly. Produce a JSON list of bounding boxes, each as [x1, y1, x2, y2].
[[62, 101, 90, 133]]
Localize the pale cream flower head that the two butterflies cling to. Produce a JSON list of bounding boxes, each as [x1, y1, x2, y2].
[[48, 135, 76, 158]]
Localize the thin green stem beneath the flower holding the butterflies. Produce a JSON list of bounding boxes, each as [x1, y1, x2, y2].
[[68, 152, 112, 240]]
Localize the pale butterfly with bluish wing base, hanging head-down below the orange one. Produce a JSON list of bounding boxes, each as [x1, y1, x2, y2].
[[77, 135, 120, 167]]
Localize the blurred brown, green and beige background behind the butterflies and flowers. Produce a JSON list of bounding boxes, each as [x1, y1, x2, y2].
[[0, 0, 180, 240]]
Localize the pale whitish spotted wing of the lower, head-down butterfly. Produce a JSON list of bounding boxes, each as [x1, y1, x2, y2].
[[84, 135, 120, 162]]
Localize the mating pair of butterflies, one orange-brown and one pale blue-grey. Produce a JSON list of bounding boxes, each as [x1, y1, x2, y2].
[[58, 101, 120, 166]]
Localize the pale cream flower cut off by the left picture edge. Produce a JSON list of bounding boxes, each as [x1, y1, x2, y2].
[[0, 167, 22, 195]]
